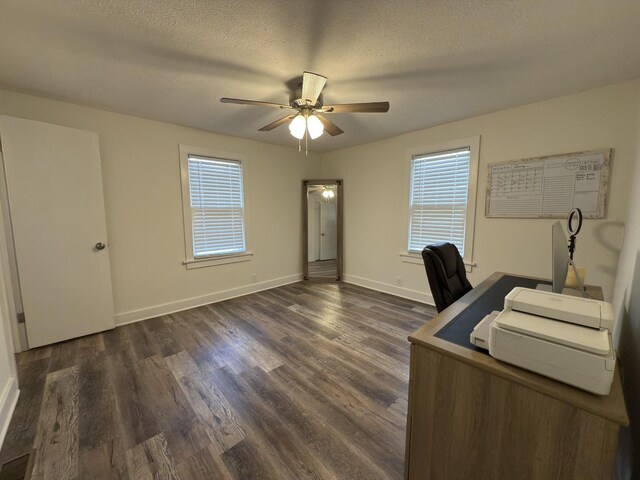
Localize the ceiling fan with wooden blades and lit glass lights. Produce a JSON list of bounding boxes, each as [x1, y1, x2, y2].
[[220, 72, 389, 140]]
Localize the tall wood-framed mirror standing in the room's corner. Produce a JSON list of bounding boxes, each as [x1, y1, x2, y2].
[[302, 180, 342, 281]]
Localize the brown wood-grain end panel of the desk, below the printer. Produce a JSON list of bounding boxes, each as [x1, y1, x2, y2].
[[407, 345, 618, 480]]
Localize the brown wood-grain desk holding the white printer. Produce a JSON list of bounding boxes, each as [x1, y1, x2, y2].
[[405, 273, 629, 480]]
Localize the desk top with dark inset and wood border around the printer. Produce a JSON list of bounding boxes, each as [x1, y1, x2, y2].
[[409, 272, 629, 426]]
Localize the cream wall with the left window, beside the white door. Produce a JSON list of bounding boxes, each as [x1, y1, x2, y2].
[[0, 90, 318, 323]]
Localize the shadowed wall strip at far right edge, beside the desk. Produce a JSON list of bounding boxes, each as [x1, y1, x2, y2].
[[613, 83, 640, 479]]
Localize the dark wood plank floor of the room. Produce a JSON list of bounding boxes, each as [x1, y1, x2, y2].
[[0, 283, 435, 480]]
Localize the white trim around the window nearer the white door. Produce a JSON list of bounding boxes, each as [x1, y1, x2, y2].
[[178, 144, 253, 270]]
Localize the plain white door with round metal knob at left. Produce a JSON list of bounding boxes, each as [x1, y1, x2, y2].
[[0, 116, 115, 348]]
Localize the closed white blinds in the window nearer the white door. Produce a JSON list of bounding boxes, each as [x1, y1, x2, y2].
[[188, 155, 246, 258]]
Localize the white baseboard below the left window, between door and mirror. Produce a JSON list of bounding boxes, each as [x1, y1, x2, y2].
[[115, 273, 302, 325]]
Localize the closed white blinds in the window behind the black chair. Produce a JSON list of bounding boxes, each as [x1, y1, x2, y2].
[[408, 147, 470, 256]]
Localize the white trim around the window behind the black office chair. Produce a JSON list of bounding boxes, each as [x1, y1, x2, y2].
[[400, 135, 480, 272]]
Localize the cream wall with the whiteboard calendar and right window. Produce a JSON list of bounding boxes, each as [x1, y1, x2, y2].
[[322, 81, 638, 300]]
